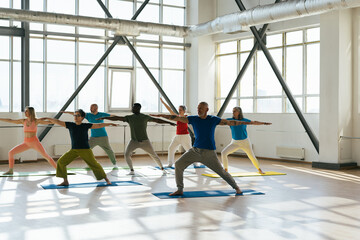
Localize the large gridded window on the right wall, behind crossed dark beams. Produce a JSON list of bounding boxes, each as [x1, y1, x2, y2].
[[216, 28, 320, 113]]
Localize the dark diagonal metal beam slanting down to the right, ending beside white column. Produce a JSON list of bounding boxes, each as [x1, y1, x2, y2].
[[235, 0, 319, 153]]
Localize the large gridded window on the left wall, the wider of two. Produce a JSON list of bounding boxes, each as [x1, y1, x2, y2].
[[0, 0, 186, 112]]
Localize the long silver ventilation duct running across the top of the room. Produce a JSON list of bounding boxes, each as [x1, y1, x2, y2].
[[0, 0, 360, 37]]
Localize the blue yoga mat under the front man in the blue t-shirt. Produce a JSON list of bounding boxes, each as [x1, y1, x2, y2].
[[153, 189, 265, 199]]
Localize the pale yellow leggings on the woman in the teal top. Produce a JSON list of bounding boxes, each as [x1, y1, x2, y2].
[[221, 138, 260, 170]]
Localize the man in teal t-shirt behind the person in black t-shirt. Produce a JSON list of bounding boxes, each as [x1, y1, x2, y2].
[[64, 103, 118, 170]]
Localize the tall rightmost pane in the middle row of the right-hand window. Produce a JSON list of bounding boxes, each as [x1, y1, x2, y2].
[[306, 43, 320, 94]]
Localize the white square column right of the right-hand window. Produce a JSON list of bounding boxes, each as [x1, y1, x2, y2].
[[319, 9, 353, 165]]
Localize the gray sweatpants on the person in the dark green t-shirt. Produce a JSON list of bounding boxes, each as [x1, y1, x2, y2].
[[125, 140, 163, 169]]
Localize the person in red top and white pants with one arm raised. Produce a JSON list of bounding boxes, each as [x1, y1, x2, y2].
[[160, 98, 192, 167]]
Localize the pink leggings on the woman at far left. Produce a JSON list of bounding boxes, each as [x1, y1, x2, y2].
[[9, 136, 56, 168]]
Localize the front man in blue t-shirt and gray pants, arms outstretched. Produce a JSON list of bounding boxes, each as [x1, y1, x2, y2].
[[152, 102, 252, 196]]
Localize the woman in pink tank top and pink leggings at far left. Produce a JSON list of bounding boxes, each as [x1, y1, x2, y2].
[[0, 107, 56, 175]]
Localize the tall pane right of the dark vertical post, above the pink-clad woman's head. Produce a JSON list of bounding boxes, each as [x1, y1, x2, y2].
[[30, 63, 44, 112]]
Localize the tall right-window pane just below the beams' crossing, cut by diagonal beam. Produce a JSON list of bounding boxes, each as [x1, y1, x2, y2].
[[257, 49, 282, 96]]
